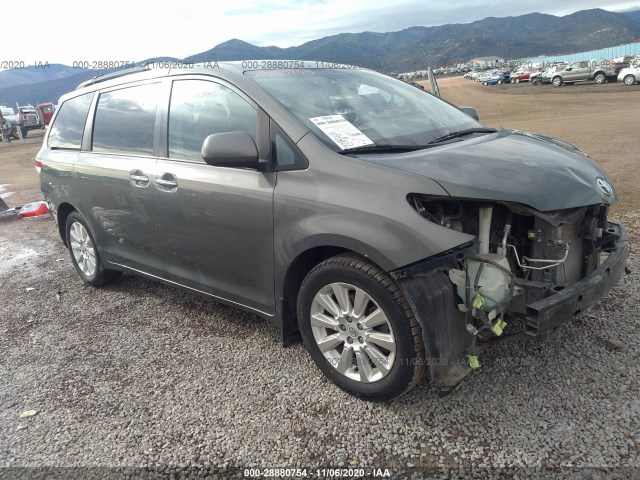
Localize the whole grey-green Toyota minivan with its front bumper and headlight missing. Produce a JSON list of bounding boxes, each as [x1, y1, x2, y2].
[[36, 60, 629, 401]]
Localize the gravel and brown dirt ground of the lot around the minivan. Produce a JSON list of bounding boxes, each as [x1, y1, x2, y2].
[[0, 78, 640, 478]]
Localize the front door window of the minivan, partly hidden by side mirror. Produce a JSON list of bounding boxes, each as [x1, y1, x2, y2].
[[169, 80, 258, 162]]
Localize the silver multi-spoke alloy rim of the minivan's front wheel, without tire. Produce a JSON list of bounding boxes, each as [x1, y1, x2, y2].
[[311, 283, 396, 383]]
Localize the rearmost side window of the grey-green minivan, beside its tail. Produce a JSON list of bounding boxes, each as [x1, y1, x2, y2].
[[47, 92, 93, 150]]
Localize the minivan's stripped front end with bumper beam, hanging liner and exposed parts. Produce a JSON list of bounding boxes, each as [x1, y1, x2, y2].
[[392, 195, 629, 391]]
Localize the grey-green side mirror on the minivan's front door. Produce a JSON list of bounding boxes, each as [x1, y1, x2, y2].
[[202, 132, 258, 169]]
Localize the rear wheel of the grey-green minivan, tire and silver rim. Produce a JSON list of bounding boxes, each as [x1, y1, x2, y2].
[[65, 212, 122, 287]]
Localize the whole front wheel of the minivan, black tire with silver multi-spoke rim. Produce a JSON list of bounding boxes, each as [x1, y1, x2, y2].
[[297, 255, 425, 401]]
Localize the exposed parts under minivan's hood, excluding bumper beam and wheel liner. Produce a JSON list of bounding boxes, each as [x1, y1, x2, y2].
[[400, 195, 620, 388]]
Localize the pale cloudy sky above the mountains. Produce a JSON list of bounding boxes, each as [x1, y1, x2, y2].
[[8, 0, 640, 68]]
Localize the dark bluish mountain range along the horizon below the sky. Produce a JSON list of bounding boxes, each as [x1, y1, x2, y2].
[[0, 9, 640, 105]]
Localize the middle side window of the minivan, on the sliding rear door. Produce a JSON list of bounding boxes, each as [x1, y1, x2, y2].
[[93, 83, 161, 155]]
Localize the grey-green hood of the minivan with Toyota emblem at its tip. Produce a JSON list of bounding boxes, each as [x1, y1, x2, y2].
[[359, 129, 617, 212]]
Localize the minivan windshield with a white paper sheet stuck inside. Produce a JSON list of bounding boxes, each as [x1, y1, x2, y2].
[[245, 69, 482, 151]]
